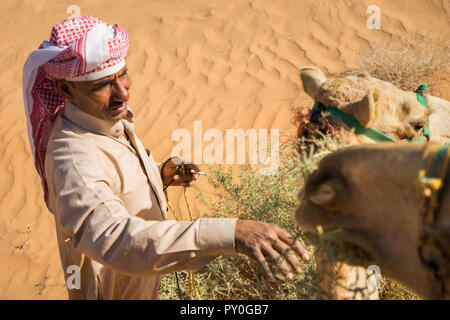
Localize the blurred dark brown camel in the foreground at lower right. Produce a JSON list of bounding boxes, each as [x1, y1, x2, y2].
[[296, 143, 450, 299]]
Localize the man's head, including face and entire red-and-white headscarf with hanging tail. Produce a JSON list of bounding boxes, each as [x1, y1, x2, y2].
[[23, 16, 130, 202]]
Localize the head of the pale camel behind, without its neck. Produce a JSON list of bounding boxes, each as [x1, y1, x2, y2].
[[299, 66, 438, 144]]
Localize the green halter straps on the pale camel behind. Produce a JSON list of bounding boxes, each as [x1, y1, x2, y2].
[[310, 83, 430, 143]]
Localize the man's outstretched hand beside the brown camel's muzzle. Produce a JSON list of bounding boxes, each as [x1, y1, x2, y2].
[[235, 220, 309, 281]]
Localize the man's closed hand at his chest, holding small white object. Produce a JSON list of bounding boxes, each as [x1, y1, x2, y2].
[[162, 157, 200, 187]]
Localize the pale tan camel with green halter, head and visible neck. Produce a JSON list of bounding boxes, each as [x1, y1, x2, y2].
[[297, 66, 450, 144]]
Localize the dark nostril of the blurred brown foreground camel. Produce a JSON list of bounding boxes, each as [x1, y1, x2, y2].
[[306, 178, 346, 210]]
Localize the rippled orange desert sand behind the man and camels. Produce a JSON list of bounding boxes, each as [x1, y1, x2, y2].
[[0, 0, 450, 299]]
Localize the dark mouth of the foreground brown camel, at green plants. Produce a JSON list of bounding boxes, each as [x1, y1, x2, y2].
[[304, 229, 375, 266]]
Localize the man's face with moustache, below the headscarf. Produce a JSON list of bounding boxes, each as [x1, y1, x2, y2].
[[56, 66, 130, 122]]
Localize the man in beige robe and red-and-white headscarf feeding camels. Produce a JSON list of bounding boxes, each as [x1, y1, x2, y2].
[[23, 17, 308, 299]]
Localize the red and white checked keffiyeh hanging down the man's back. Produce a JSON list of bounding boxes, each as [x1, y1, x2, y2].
[[23, 16, 129, 206]]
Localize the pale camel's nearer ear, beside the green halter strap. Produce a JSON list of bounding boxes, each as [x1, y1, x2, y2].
[[351, 87, 382, 128]]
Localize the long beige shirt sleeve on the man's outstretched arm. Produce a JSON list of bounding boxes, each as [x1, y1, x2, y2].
[[46, 133, 236, 276]]
